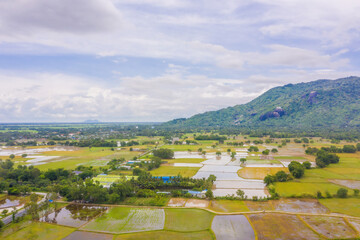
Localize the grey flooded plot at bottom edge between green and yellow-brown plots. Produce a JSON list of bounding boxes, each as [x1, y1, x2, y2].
[[211, 215, 255, 240]]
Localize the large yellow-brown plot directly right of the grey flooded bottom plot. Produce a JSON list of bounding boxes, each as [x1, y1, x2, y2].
[[249, 213, 320, 240]]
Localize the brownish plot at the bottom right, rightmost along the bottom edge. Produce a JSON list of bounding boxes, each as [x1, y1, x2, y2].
[[302, 216, 357, 239]]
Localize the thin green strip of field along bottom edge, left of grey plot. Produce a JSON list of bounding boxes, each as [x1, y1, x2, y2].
[[115, 231, 213, 240]]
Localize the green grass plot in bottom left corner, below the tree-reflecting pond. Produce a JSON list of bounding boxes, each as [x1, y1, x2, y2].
[[4, 222, 76, 240]]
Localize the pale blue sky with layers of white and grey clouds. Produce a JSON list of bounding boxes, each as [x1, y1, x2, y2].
[[0, 0, 360, 123]]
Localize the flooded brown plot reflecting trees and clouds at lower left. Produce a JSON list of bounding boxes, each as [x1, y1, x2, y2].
[[40, 204, 107, 227]]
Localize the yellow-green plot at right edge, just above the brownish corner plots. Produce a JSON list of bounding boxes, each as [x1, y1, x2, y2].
[[319, 198, 360, 217]]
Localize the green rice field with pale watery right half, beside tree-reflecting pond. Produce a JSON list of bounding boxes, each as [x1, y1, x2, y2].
[[82, 207, 165, 233]]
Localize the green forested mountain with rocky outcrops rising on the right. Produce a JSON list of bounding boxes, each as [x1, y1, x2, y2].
[[164, 77, 360, 129]]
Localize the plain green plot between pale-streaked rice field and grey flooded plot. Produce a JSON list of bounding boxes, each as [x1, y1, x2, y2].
[[165, 208, 214, 232]]
